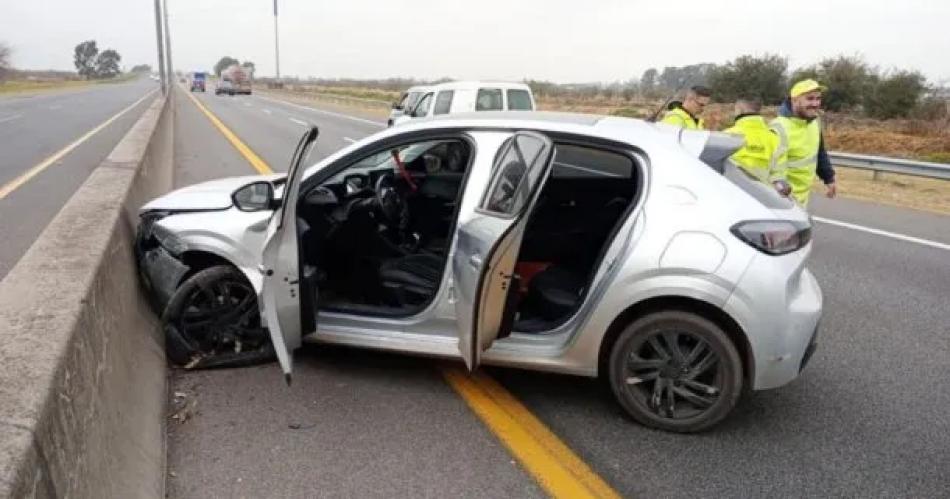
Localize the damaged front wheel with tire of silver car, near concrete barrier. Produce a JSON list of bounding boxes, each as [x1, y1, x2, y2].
[[162, 265, 273, 368]]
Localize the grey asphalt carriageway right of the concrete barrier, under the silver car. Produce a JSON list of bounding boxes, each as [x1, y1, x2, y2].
[[169, 88, 950, 497]]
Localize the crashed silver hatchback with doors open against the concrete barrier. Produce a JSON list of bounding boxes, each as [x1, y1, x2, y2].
[[136, 112, 822, 432]]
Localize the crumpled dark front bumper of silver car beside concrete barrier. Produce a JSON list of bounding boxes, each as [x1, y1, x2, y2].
[[135, 213, 189, 315]]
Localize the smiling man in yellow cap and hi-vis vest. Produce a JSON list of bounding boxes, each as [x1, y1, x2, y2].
[[771, 79, 838, 208]]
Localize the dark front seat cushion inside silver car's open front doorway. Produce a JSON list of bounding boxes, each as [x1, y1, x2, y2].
[[379, 253, 442, 305]]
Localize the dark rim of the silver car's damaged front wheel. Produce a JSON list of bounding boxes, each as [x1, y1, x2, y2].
[[175, 277, 266, 354]]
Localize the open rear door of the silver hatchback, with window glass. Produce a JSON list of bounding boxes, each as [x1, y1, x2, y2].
[[452, 132, 554, 369]]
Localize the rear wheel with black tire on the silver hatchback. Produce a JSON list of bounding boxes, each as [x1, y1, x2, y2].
[[608, 310, 743, 433]]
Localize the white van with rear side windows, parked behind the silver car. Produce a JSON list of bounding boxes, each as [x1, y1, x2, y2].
[[395, 81, 535, 124]]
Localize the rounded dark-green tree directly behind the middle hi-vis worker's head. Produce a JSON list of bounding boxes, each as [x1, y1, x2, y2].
[[709, 54, 788, 104]]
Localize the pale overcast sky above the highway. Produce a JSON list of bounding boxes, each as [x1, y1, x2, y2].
[[0, 0, 950, 83]]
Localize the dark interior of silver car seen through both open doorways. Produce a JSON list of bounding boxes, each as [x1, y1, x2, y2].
[[297, 139, 636, 333]]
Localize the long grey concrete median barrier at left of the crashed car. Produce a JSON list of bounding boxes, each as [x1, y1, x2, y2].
[[0, 91, 174, 498]]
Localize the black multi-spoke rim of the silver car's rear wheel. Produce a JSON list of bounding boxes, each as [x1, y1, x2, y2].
[[622, 330, 725, 420]]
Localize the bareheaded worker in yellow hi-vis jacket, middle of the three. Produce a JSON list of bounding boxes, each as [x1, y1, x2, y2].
[[723, 97, 792, 197]]
